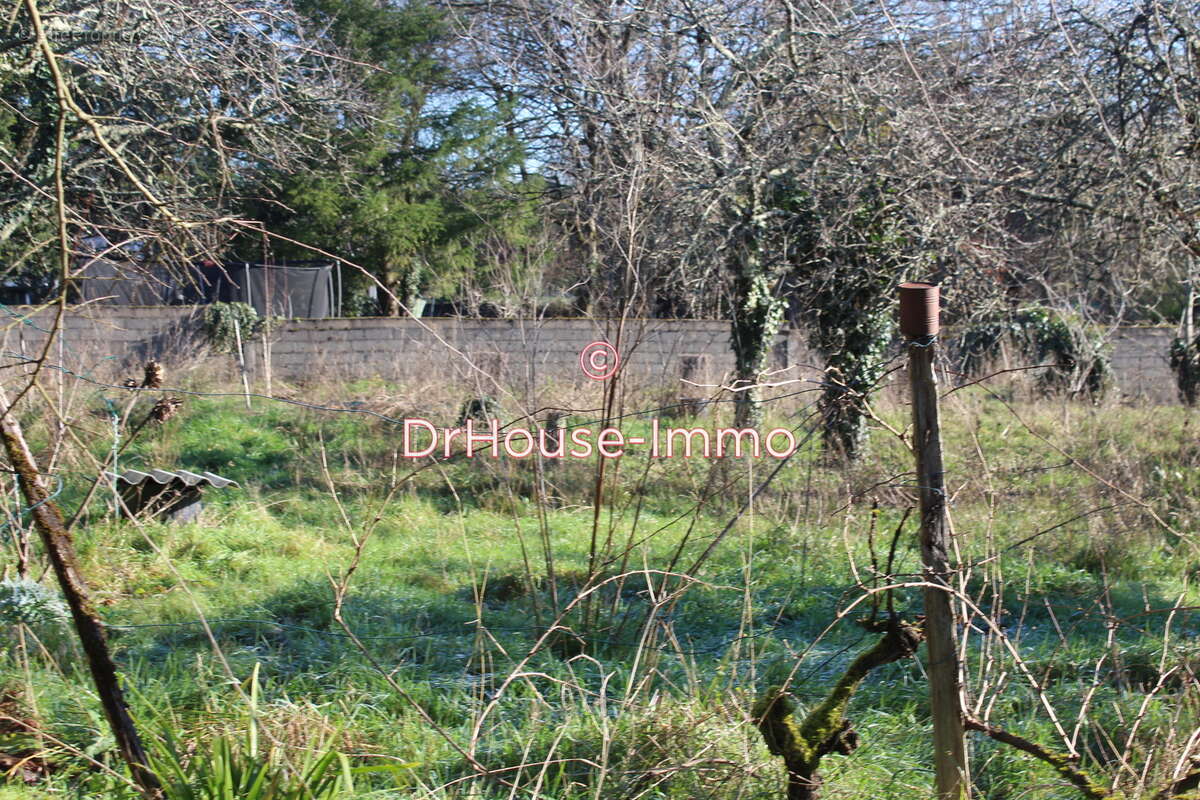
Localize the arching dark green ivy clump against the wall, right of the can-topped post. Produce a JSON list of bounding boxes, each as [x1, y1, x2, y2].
[[953, 307, 1112, 401]]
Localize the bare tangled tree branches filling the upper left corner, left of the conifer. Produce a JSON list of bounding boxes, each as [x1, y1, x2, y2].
[[0, 0, 354, 287]]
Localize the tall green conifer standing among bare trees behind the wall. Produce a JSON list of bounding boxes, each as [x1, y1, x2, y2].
[[247, 0, 533, 315]]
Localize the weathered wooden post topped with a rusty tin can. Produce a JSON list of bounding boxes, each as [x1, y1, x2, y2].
[[900, 283, 971, 800]]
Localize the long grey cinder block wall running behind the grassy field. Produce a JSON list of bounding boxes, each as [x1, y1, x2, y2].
[[0, 305, 1177, 403]]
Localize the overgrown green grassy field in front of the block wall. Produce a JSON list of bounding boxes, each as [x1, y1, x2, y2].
[[0, 376, 1200, 800]]
